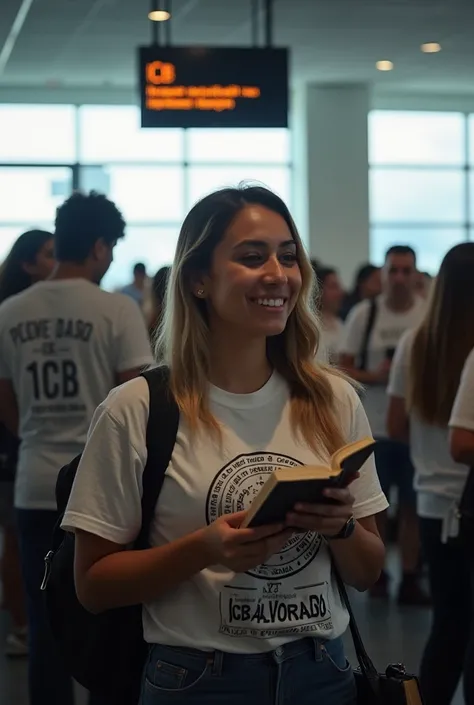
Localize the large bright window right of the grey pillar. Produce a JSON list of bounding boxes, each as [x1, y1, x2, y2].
[[369, 111, 474, 274]]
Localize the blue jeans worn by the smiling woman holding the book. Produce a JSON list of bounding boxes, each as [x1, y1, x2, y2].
[[140, 639, 356, 705]]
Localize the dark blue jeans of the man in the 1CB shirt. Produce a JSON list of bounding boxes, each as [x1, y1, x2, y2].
[[16, 509, 74, 705]]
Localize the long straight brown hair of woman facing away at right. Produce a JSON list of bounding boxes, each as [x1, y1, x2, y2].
[[408, 242, 474, 427]]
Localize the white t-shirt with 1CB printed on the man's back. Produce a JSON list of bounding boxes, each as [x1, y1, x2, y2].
[[0, 279, 152, 509]]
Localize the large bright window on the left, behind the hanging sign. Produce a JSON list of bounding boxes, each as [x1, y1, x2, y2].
[[0, 104, 291, 289]]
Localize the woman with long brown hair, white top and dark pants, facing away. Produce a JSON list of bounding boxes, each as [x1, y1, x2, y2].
[[387, 243, 474, 705]]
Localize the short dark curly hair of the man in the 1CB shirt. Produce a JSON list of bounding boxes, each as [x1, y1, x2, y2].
[[54, 191, 125, 263]]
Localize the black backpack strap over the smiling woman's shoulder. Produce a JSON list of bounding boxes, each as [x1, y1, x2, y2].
[[135, 367, 179, 548]]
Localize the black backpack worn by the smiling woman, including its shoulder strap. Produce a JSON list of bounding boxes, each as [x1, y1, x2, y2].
[[41, 368, 179, 705]]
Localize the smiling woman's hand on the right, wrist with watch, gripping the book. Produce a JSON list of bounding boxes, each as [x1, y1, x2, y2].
[[286, 488, 354, 538]]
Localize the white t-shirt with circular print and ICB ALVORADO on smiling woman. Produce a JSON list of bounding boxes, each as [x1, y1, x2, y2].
[[63, 373, 387, 653]]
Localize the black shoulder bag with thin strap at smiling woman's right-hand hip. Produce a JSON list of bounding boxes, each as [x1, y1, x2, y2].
[[333, 564, 424, 705]]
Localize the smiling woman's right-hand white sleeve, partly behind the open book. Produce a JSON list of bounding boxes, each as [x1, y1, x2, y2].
[[350, 390, 388, 519]]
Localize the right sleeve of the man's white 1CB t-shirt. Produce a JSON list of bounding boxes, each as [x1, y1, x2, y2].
[[115, 294, 153, 372]]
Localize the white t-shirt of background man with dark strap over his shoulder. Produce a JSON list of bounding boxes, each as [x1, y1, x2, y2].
[[341, 296, 425, 438]]
